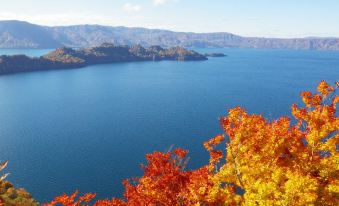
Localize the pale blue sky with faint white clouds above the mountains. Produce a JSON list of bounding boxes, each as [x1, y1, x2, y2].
[[0, 0, 339, 38]]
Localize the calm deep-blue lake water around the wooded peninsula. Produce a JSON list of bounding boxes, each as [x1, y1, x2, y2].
[[0, 49, 339, 202]]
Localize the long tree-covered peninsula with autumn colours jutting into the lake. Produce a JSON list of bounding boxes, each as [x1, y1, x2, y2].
[[0, 43, 207, 74]]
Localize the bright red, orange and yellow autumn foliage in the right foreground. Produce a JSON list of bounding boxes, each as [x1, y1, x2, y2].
[[46, 81, 339, 206]]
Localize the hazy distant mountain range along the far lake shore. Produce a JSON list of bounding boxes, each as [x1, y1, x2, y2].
[[0, 20, 339, 50]]
